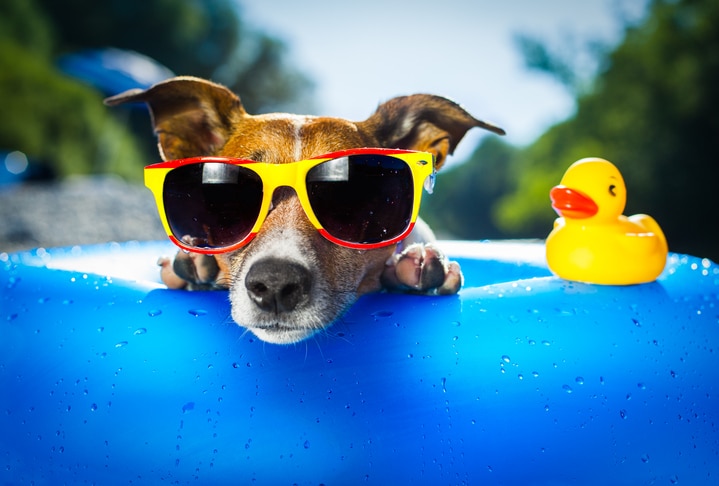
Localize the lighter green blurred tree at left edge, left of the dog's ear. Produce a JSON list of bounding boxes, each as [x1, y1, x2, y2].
[[0, 0, 143, 178]]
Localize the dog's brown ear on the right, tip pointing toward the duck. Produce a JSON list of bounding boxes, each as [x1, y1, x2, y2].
[[360, 94, 505, 169]]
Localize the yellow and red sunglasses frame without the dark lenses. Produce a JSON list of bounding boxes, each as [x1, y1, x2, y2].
[[145, 148, 435, 255]]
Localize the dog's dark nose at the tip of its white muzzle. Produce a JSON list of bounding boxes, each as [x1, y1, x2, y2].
[[245, 258, 312, 313]]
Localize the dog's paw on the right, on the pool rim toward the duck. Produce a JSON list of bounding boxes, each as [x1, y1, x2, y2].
[[382, 243, 463, 295]]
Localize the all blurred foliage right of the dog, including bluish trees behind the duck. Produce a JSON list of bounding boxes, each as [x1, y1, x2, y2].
[[423, 0, 719, 260]]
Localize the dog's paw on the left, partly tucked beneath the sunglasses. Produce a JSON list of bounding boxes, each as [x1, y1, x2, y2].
[[157, 251, 227, 290]]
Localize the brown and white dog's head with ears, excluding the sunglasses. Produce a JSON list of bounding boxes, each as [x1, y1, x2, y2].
[[108, 77, 503, 343]]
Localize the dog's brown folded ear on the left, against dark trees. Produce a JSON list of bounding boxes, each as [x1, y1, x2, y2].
[[105, 76, 246, 160]]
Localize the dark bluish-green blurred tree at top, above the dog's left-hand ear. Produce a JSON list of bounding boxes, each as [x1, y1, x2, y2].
[[37, 0, 312, 112]]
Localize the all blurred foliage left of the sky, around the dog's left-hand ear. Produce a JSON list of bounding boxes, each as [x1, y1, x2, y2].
[[0, 0, 312, 179]]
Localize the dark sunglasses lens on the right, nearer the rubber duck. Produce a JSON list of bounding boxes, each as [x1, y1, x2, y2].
[[306, 154, 414, 244]]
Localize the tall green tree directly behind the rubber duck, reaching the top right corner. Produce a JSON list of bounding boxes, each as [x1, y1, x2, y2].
[[504, 0, 719, 258]]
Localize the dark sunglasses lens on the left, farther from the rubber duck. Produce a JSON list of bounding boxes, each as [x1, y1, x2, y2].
[[163, 162, 262, 248]]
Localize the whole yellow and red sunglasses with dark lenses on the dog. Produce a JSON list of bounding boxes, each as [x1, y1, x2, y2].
[[145, 148, 435, 254]]
